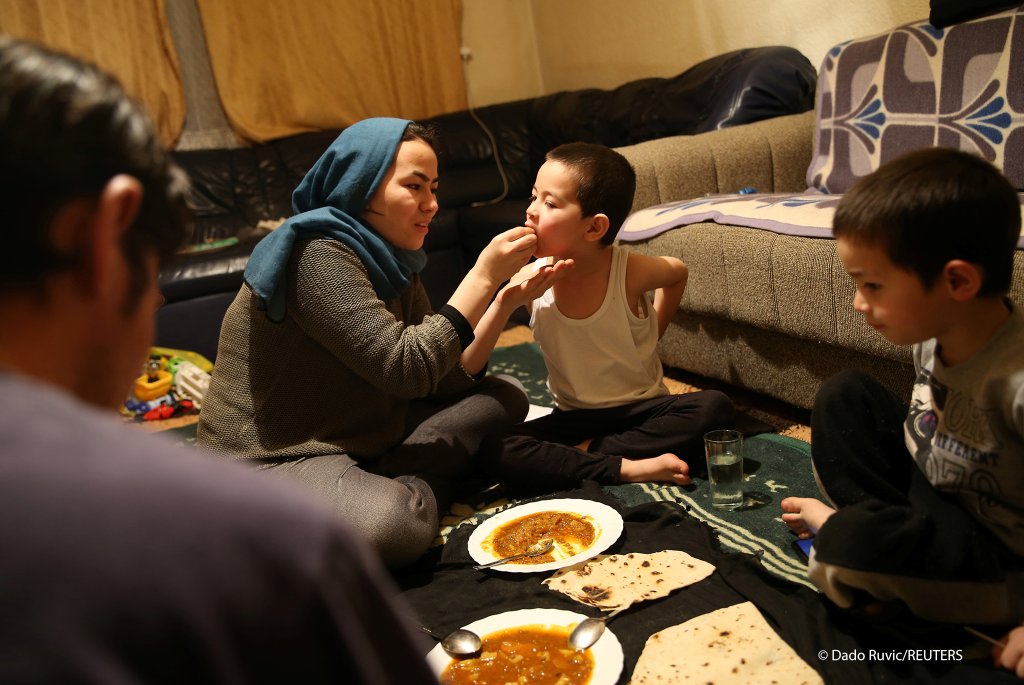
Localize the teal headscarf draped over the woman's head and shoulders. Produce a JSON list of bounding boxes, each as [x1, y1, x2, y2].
[[245, 118, 427, 323]]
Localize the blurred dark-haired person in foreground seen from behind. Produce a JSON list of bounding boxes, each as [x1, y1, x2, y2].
[[0, 37, 434, 683]]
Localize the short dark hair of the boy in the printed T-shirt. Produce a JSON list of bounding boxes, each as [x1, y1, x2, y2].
[[833, 147, 1021, 296]]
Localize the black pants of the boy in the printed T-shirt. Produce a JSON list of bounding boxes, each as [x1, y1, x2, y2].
[[809, 371, 1024, 625]]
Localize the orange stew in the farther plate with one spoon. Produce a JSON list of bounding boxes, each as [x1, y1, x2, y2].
[[492, 511, 596, 564]]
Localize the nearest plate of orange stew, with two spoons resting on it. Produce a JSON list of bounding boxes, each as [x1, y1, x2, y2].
[[427, 609, 624, 685]]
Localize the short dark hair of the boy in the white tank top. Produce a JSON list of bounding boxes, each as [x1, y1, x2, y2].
[[546, 142, 637, 245]]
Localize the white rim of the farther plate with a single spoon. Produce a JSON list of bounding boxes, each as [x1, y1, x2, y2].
[[469, 500, 623, 573]]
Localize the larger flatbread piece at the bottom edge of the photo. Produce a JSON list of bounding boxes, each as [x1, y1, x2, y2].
[[630, 602, 824, 685]]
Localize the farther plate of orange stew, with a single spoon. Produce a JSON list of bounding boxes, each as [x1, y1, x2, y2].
[[468, 499, 623, 573]]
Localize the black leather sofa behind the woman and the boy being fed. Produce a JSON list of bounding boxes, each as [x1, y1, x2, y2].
[[157, 47, 816, 359]]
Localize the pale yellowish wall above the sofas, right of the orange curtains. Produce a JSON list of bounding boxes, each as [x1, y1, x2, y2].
[[463, 0, 929, 106]]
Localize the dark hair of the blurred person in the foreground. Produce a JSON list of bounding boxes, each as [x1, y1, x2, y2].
[[0, 37, 190, 290]]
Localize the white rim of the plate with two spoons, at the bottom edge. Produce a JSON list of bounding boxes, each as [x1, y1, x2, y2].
[[427, 609, 624, 685]]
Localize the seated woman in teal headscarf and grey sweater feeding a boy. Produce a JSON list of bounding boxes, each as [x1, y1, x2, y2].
[[199, 119, 569, 566]]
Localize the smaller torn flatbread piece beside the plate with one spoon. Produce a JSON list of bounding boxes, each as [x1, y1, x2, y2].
[[544, 550, 715, 611]]
